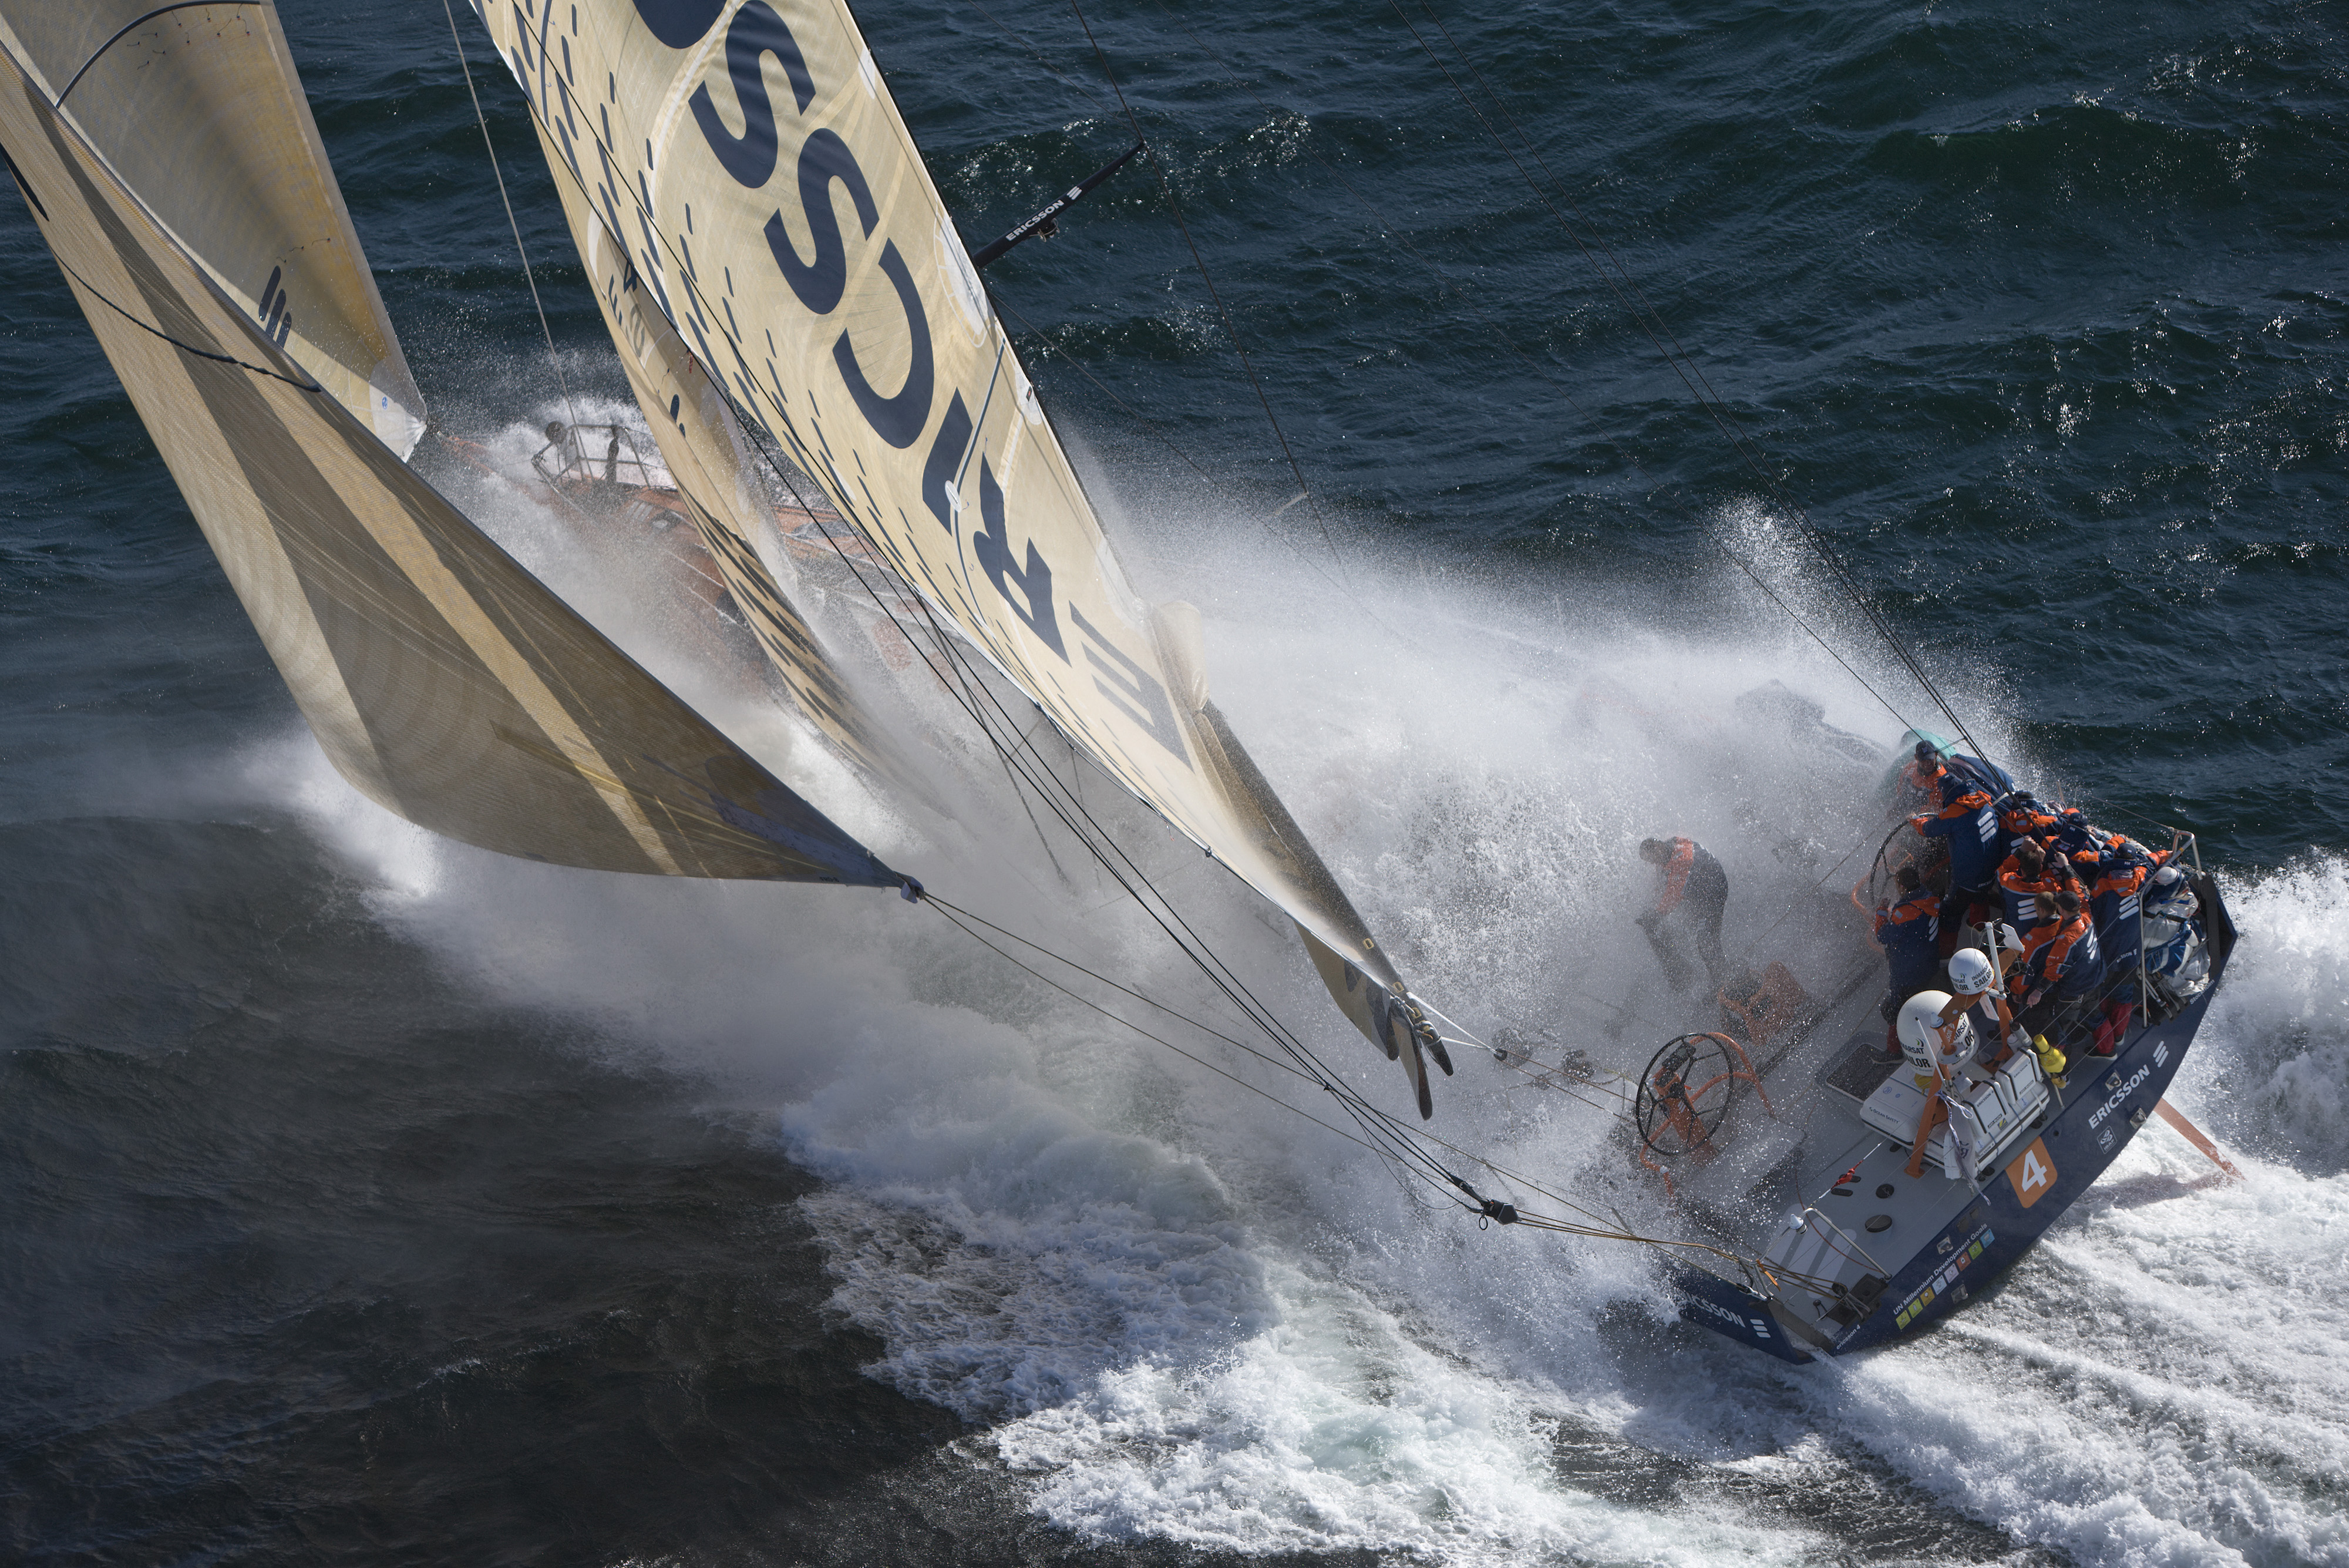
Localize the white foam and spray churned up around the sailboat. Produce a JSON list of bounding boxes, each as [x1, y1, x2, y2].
[[242, 408, 2349, 1566]]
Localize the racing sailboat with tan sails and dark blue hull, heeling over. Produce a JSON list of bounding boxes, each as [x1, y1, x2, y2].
[[0, 0, 2232, 1359]]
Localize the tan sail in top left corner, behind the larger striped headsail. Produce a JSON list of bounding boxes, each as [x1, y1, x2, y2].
[[0, 0, 425, 457]]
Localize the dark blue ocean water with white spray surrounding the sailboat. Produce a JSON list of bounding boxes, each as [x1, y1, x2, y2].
[[0, 0, 2349, 1566]]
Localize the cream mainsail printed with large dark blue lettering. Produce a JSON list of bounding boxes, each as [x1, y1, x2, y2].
[[482, 0, 1442, 1115]]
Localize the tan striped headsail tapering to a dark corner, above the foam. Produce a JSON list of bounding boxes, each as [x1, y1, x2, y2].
[[0, 52, 902, 885]]
